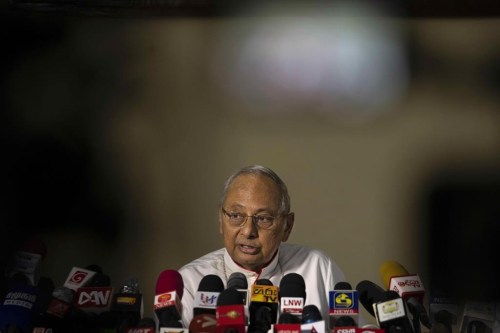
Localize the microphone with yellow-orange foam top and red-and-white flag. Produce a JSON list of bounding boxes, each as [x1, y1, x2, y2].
[[380, 261, 431, 333]]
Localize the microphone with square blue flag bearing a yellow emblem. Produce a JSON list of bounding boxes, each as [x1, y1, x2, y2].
[[329, 282, 359, 331]]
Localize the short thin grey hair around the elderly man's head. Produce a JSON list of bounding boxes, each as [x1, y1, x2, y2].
[[219, 165, 290, 214]]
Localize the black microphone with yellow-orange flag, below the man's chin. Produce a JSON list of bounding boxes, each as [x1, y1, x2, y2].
[[248, 279, 278, 333]]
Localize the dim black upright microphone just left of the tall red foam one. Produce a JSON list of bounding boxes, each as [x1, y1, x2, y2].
[[110, 277, 143, 332]]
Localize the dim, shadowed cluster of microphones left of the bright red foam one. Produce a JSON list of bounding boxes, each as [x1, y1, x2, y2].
[[0, 239, 150, 333]]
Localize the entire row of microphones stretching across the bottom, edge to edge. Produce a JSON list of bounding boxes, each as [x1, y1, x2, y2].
[[0, 237, 500, 333]]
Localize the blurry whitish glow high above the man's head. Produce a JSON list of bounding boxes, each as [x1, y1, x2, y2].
[[213, 4, 409, 116]]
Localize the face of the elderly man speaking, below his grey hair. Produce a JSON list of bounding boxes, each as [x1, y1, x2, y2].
[[219, 174, 293, 271]]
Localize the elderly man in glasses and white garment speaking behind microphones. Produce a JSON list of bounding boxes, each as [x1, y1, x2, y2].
[[179, 165, 345, 327]]
